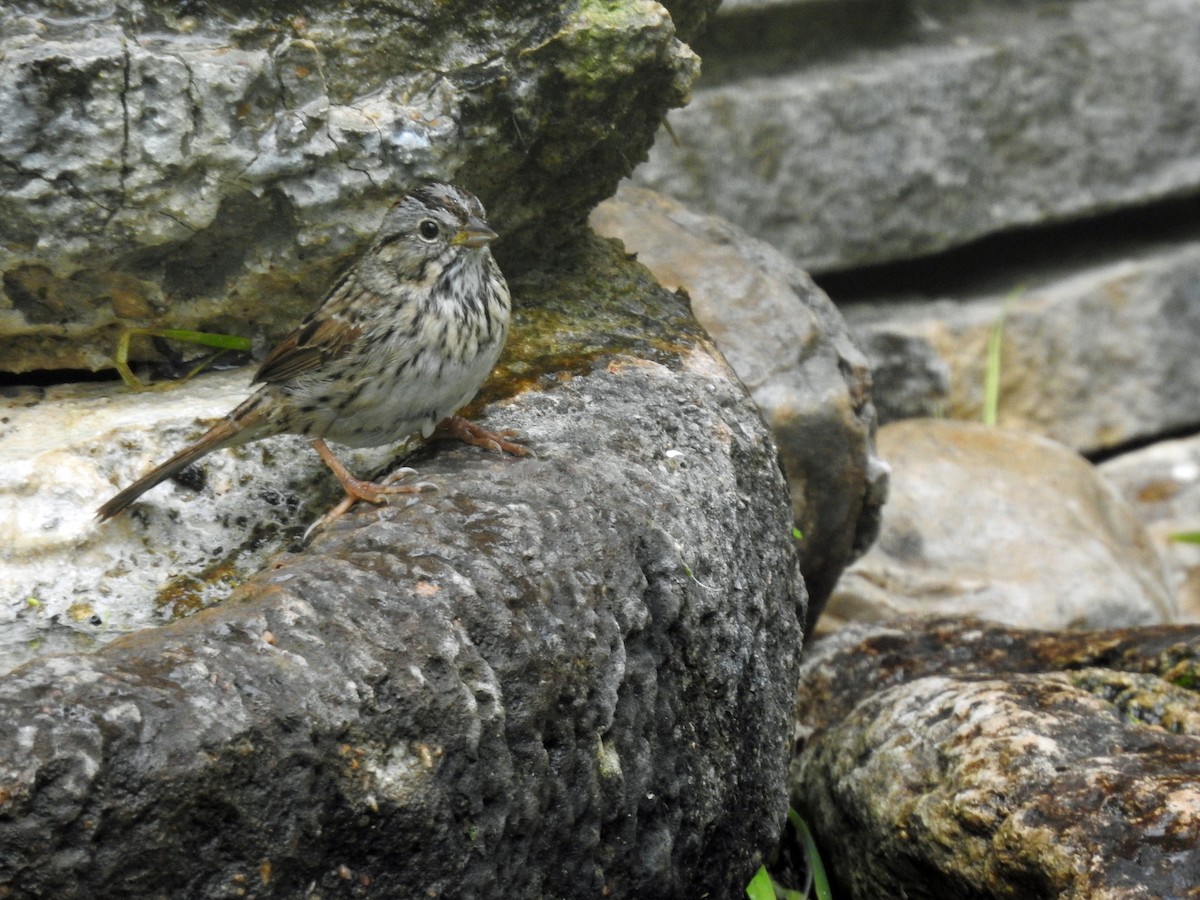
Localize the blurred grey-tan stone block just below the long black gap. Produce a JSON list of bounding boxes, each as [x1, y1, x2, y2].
[[844, 241, 1200, 452]]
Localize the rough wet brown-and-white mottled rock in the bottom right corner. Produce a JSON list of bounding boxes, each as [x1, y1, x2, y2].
[[793, 620, 1200, 900]]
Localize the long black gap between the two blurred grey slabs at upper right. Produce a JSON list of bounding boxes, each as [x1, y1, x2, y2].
[[814, 194, 1200, 306]]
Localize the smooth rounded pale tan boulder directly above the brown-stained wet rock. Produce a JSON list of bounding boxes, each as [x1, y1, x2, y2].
[[822, 419, 1176, 629]]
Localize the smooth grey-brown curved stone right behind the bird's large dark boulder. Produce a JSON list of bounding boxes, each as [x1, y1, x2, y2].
[[592, 185, 888, 626]]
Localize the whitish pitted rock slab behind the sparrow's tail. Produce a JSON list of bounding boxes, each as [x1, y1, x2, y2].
[[0, 368, 386, 670]]
